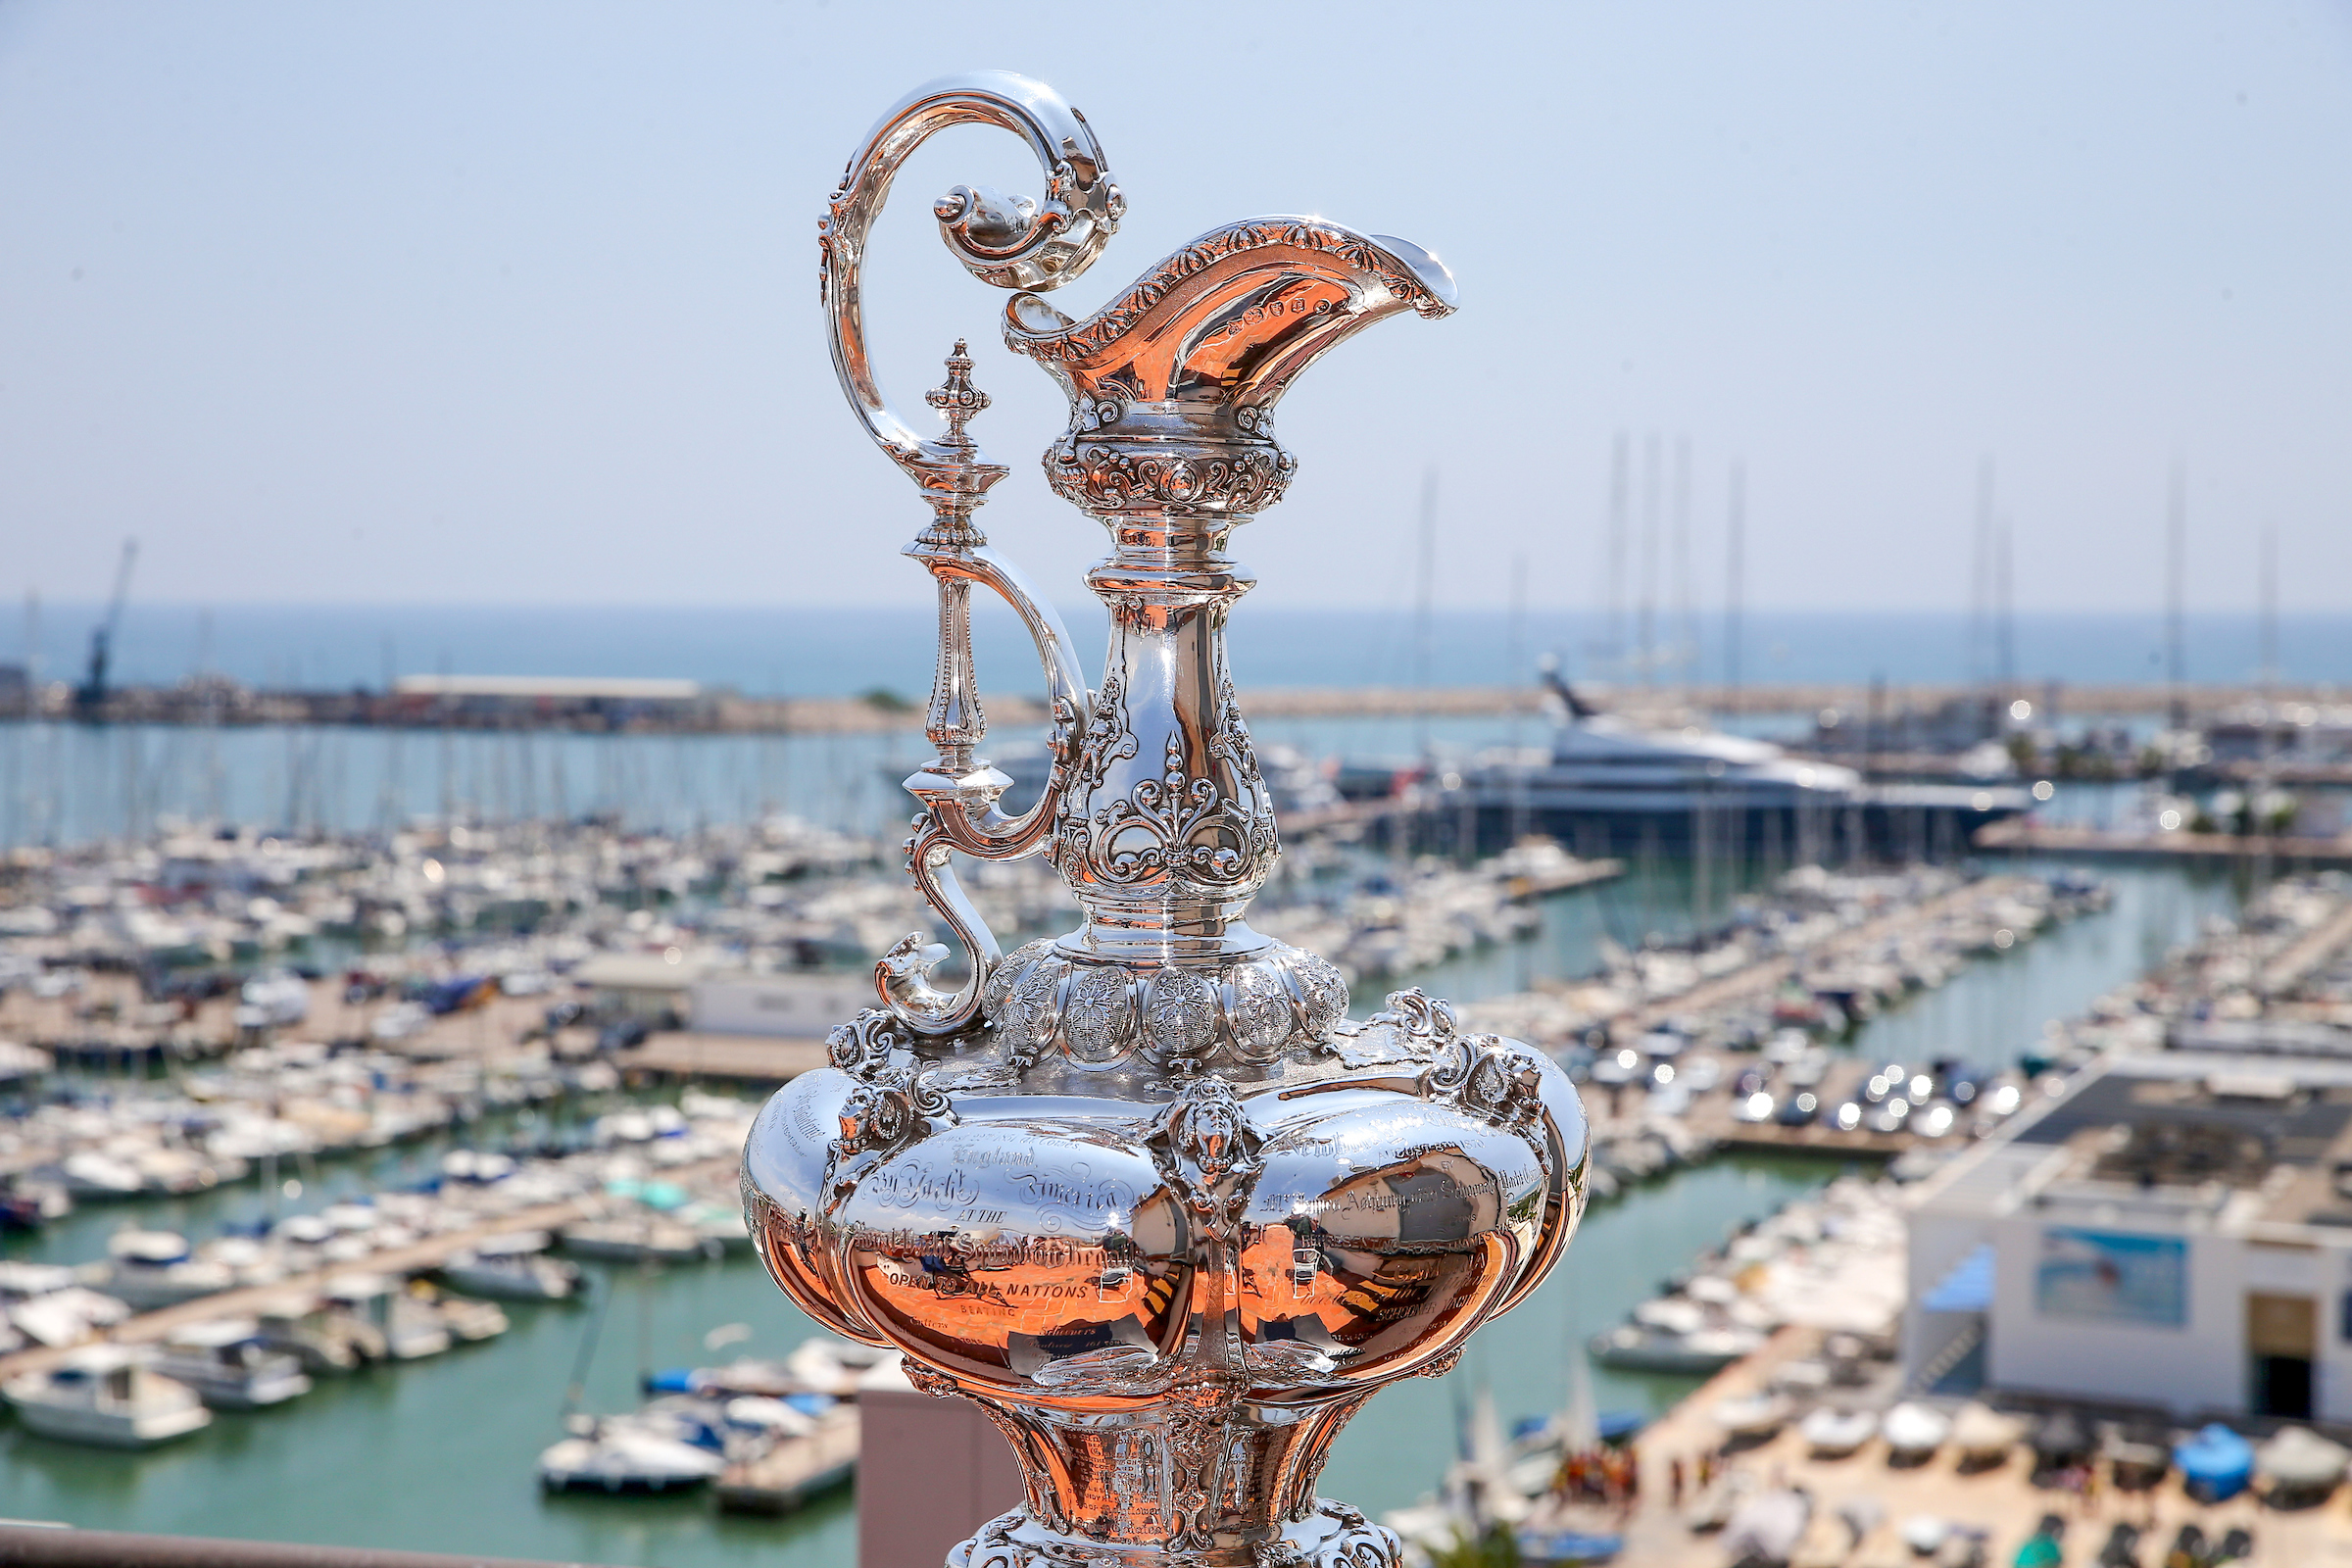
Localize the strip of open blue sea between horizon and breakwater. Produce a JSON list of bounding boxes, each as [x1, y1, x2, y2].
[[14, 602, 2352, 696]]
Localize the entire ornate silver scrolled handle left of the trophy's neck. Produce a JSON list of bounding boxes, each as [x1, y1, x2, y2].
[[816, 71, 1124, 1037]]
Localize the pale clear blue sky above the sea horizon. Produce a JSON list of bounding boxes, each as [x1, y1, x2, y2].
[[0, 0, 2352, 609]]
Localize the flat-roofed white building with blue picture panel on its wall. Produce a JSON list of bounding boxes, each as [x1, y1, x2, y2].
[[1903, 1048, 2352, 1422]]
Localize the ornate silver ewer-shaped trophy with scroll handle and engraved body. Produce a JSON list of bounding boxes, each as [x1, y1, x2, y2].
[[743, 73, 1588, 1568]]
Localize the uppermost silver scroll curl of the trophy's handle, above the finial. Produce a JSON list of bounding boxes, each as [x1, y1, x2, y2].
[[816, 71, 1127, 489]]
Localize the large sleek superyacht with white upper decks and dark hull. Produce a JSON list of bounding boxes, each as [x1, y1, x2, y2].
[[1460, 670, 2033, 860]]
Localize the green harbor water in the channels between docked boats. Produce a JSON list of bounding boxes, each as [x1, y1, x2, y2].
[[0, 870, 2239, 1568]]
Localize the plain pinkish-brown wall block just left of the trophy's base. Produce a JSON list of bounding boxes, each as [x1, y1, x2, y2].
[[858, 1387, 1021, 1568]]
